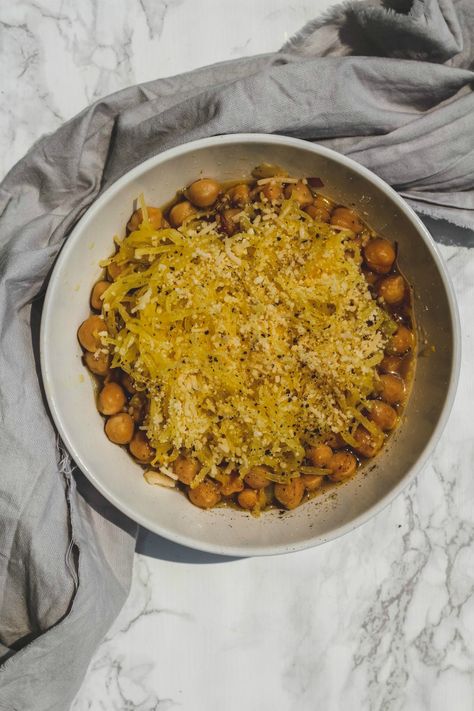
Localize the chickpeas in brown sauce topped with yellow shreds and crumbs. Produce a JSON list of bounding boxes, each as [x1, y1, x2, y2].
[[78, 165, 416, 514]]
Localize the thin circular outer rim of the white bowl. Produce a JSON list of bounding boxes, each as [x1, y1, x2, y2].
[[40, 133, 461, 557]]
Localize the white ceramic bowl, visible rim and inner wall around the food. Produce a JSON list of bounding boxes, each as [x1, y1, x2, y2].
[[41, 134, 460, 556]]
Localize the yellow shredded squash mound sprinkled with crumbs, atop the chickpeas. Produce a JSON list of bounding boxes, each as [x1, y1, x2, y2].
[[102, 198, 393, 486]]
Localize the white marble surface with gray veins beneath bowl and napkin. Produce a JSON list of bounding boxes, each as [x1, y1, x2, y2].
[[0, 0, 474, 711]]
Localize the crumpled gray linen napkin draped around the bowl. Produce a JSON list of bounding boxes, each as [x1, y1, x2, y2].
[[0, 0, 474, 711]]
